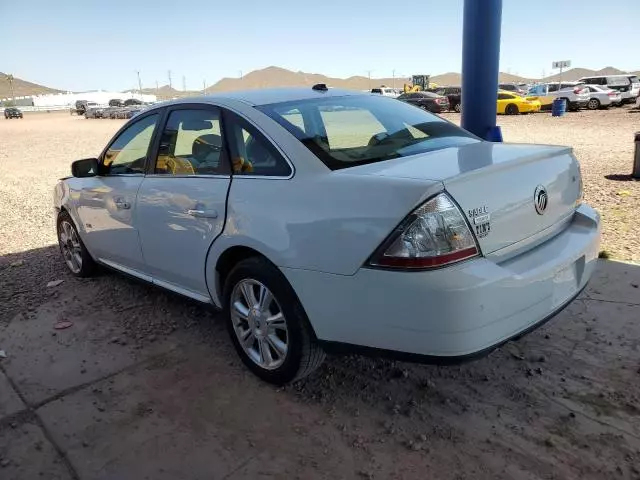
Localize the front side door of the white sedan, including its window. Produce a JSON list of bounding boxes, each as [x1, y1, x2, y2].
[[77, 109, 160, 275]]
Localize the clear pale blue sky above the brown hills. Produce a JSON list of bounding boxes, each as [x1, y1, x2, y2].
[[0, 0, 640, 91]]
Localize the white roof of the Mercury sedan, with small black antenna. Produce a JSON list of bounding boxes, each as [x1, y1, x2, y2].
[[157, 86, 364, 106]]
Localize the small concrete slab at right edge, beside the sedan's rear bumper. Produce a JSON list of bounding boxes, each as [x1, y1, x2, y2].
[[585, 260, 640, 305]]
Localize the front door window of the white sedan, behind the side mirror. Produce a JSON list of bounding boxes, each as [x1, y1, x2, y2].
[[101, 113, 160, 175]]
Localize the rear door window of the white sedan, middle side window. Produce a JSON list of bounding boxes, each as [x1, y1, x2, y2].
[[154, 108, 229, 175]]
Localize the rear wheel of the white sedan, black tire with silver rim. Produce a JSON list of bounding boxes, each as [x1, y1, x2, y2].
[[223, 257, 325, 385]]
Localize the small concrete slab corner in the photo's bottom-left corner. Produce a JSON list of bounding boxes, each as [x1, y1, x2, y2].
[[0, 421, 73, 480]]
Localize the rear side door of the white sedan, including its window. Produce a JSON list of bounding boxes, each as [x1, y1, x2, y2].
[[136, 104, 231, 301]]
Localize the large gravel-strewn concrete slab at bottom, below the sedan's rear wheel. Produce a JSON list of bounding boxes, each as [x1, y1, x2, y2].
[[38, 345, 360, 480]]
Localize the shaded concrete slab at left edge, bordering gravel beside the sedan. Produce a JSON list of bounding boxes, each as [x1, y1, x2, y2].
[[0, 292, 180, 405]]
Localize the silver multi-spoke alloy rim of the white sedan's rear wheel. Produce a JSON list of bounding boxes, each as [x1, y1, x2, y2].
[[229, 278, 289, 370]]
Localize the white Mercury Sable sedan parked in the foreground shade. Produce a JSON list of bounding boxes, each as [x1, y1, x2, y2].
[[54, 85, 600, 384]]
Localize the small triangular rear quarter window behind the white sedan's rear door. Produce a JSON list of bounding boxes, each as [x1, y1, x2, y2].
[[225, 112, 292, 177]]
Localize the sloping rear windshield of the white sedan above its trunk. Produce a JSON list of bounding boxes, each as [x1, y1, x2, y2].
[[257, 95, 480, 170]]
